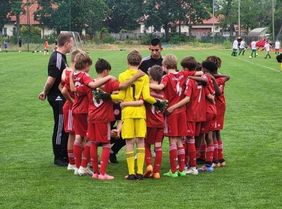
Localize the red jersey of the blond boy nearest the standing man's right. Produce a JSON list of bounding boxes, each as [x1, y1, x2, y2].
[[72, 71, 93, 114]]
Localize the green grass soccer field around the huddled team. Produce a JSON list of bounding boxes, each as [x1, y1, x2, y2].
[[0, 48, 282, 209]]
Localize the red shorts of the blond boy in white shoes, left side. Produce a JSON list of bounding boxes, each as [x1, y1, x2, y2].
[[72, 113, 87, 137]]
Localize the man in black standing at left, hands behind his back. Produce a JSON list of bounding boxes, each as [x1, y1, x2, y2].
[[39, 33, 73, 166]]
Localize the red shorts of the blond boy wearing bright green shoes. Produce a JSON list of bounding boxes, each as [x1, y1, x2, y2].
[[164, 111, 187, 137]]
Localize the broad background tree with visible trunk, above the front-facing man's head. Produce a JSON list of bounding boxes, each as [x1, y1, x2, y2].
[[144, 0, 210, 41]]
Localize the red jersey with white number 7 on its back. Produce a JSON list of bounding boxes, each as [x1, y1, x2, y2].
[[184, 79, 206, 122]]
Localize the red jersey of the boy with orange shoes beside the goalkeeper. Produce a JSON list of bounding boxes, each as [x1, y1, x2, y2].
[[145, 89, 164, 128]]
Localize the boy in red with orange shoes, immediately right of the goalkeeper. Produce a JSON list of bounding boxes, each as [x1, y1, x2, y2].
[[144, 65, 164, 179]]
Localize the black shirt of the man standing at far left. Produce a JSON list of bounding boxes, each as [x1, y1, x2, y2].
[[47, 51, 67, 96]]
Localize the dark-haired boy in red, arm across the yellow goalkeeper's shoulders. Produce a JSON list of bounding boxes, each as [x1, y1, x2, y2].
[[87, 59, 144, 180]]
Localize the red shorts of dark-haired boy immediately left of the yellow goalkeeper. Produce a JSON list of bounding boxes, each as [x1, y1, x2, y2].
[[87, 121, 111, 143]]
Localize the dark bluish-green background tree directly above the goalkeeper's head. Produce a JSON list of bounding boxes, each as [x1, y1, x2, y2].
[[105, 0, 143, 33]]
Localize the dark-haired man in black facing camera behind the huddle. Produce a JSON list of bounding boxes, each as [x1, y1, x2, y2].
[[139, 38, 163, 74]]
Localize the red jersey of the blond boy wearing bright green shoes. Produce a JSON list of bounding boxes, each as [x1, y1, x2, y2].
[[161, 71, 186, 114]]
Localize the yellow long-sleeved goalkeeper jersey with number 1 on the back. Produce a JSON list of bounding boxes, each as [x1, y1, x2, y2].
[[112, 69, 156, 119]]
